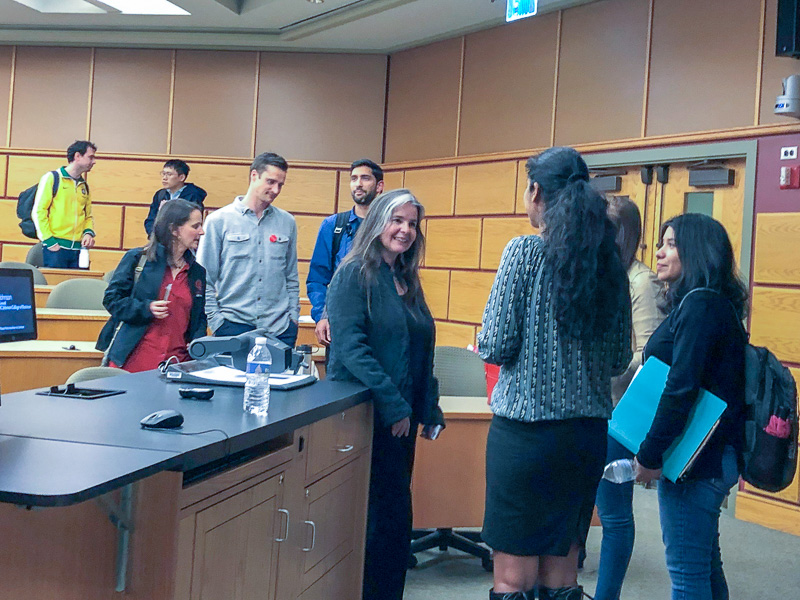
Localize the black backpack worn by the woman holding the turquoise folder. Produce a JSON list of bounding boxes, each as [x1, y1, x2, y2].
[[679, 288, 798, 492]]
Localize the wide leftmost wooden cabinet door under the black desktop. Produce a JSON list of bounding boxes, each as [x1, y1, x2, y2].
[[191, 475, 286, 600]]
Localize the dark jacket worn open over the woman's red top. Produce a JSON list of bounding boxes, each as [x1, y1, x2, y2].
[[96, 245, 207, 365]]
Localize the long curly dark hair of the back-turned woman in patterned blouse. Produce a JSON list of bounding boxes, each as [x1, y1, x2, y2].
[[526, 148, 629, 339]]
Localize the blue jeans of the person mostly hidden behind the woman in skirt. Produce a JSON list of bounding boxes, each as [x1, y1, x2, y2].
[[594, 436, 636, 600]]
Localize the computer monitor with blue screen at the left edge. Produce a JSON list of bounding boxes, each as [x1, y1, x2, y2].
[[0, 268, 36, 342]]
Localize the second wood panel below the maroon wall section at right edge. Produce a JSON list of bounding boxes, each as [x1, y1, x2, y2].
[[750, 286, 800, 363]]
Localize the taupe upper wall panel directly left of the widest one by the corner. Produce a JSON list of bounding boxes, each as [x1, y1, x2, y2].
[[171, 50, 256, 157]]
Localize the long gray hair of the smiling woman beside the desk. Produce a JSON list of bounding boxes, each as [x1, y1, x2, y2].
[[342, 189, 425, 304]]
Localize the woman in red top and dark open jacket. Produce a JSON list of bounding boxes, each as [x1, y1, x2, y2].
[[97, 200, 207, 372]]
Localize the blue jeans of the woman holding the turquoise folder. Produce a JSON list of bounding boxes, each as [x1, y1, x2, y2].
[[658, 446, 739, 600]]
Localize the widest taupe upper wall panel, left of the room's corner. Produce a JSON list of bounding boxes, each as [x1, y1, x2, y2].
[[256, 52, 387, 162]]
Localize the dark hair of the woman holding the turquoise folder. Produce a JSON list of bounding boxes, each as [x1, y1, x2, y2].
[[659, 213, 748, 319]]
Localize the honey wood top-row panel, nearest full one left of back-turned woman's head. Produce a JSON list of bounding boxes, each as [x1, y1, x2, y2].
[[455, 161, 517, 215]]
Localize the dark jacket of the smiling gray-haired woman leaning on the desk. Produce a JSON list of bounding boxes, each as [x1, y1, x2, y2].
[[327, 261, 444, 427]]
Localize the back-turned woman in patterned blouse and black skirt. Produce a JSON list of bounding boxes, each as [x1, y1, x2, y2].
[[478, 148, 631, 600]]
